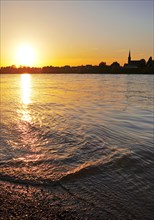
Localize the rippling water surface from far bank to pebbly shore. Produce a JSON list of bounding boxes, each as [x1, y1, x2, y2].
[[0, 74, 154, 219]]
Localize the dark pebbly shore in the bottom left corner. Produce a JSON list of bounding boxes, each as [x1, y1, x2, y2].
[[0, 181, 83, 220]]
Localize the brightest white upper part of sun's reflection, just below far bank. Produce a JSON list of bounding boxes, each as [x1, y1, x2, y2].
[[21, 74, 31, 105]]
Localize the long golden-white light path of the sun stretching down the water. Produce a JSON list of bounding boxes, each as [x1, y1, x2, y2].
[[18, 73, 43, 163]]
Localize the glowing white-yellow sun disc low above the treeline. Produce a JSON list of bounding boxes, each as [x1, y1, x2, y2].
[[16, 44, 35, 66]]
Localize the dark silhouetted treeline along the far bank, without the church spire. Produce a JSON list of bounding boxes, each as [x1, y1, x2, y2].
[[0, 62, 154, 74]]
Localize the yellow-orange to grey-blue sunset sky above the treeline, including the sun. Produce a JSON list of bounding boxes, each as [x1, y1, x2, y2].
[[0, 0, 154, 66]]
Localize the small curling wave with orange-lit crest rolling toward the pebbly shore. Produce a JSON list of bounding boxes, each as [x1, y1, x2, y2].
[[0, 148, 132, 185]]
